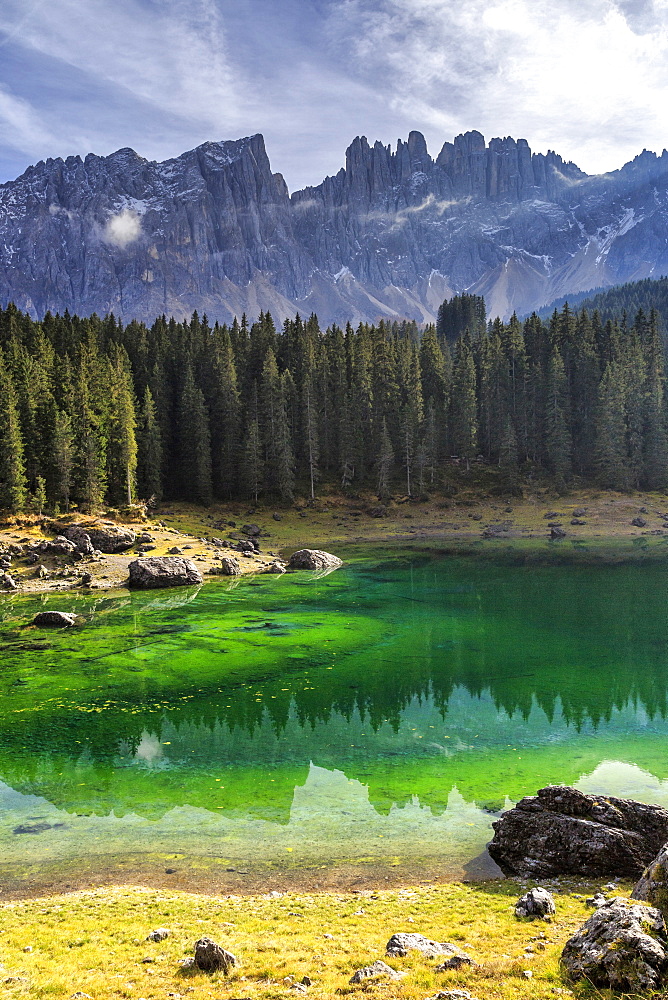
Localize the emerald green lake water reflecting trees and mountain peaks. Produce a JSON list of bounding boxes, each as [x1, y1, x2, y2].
[[0, 549, 668, 889]]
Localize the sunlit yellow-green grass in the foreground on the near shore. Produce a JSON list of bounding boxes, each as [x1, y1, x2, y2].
[[0, 881, 616, 1000]]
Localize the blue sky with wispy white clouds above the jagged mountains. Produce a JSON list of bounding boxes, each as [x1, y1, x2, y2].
[[0, 0, 668, 190]]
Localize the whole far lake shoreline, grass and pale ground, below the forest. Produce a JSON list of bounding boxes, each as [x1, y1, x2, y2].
[[0, 491, 668, 594]]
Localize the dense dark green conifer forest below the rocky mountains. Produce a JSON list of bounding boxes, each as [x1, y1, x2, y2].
[[0, 302, 668, 510]]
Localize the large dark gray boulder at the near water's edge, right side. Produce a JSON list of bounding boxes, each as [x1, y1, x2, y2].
[[487, 785, 668, 878]]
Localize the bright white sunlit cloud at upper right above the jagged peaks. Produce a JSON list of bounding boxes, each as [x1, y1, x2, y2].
[[329, 0, 668, 172]]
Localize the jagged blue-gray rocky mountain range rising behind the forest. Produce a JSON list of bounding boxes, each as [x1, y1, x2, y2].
[[0, 132, 668, 323]]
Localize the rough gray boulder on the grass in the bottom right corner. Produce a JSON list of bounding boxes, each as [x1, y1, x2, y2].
[[561, 896, 668, 993]]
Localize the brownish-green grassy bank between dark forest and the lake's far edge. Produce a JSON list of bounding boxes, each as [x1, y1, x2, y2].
[[160, 490, 668, 564]]
